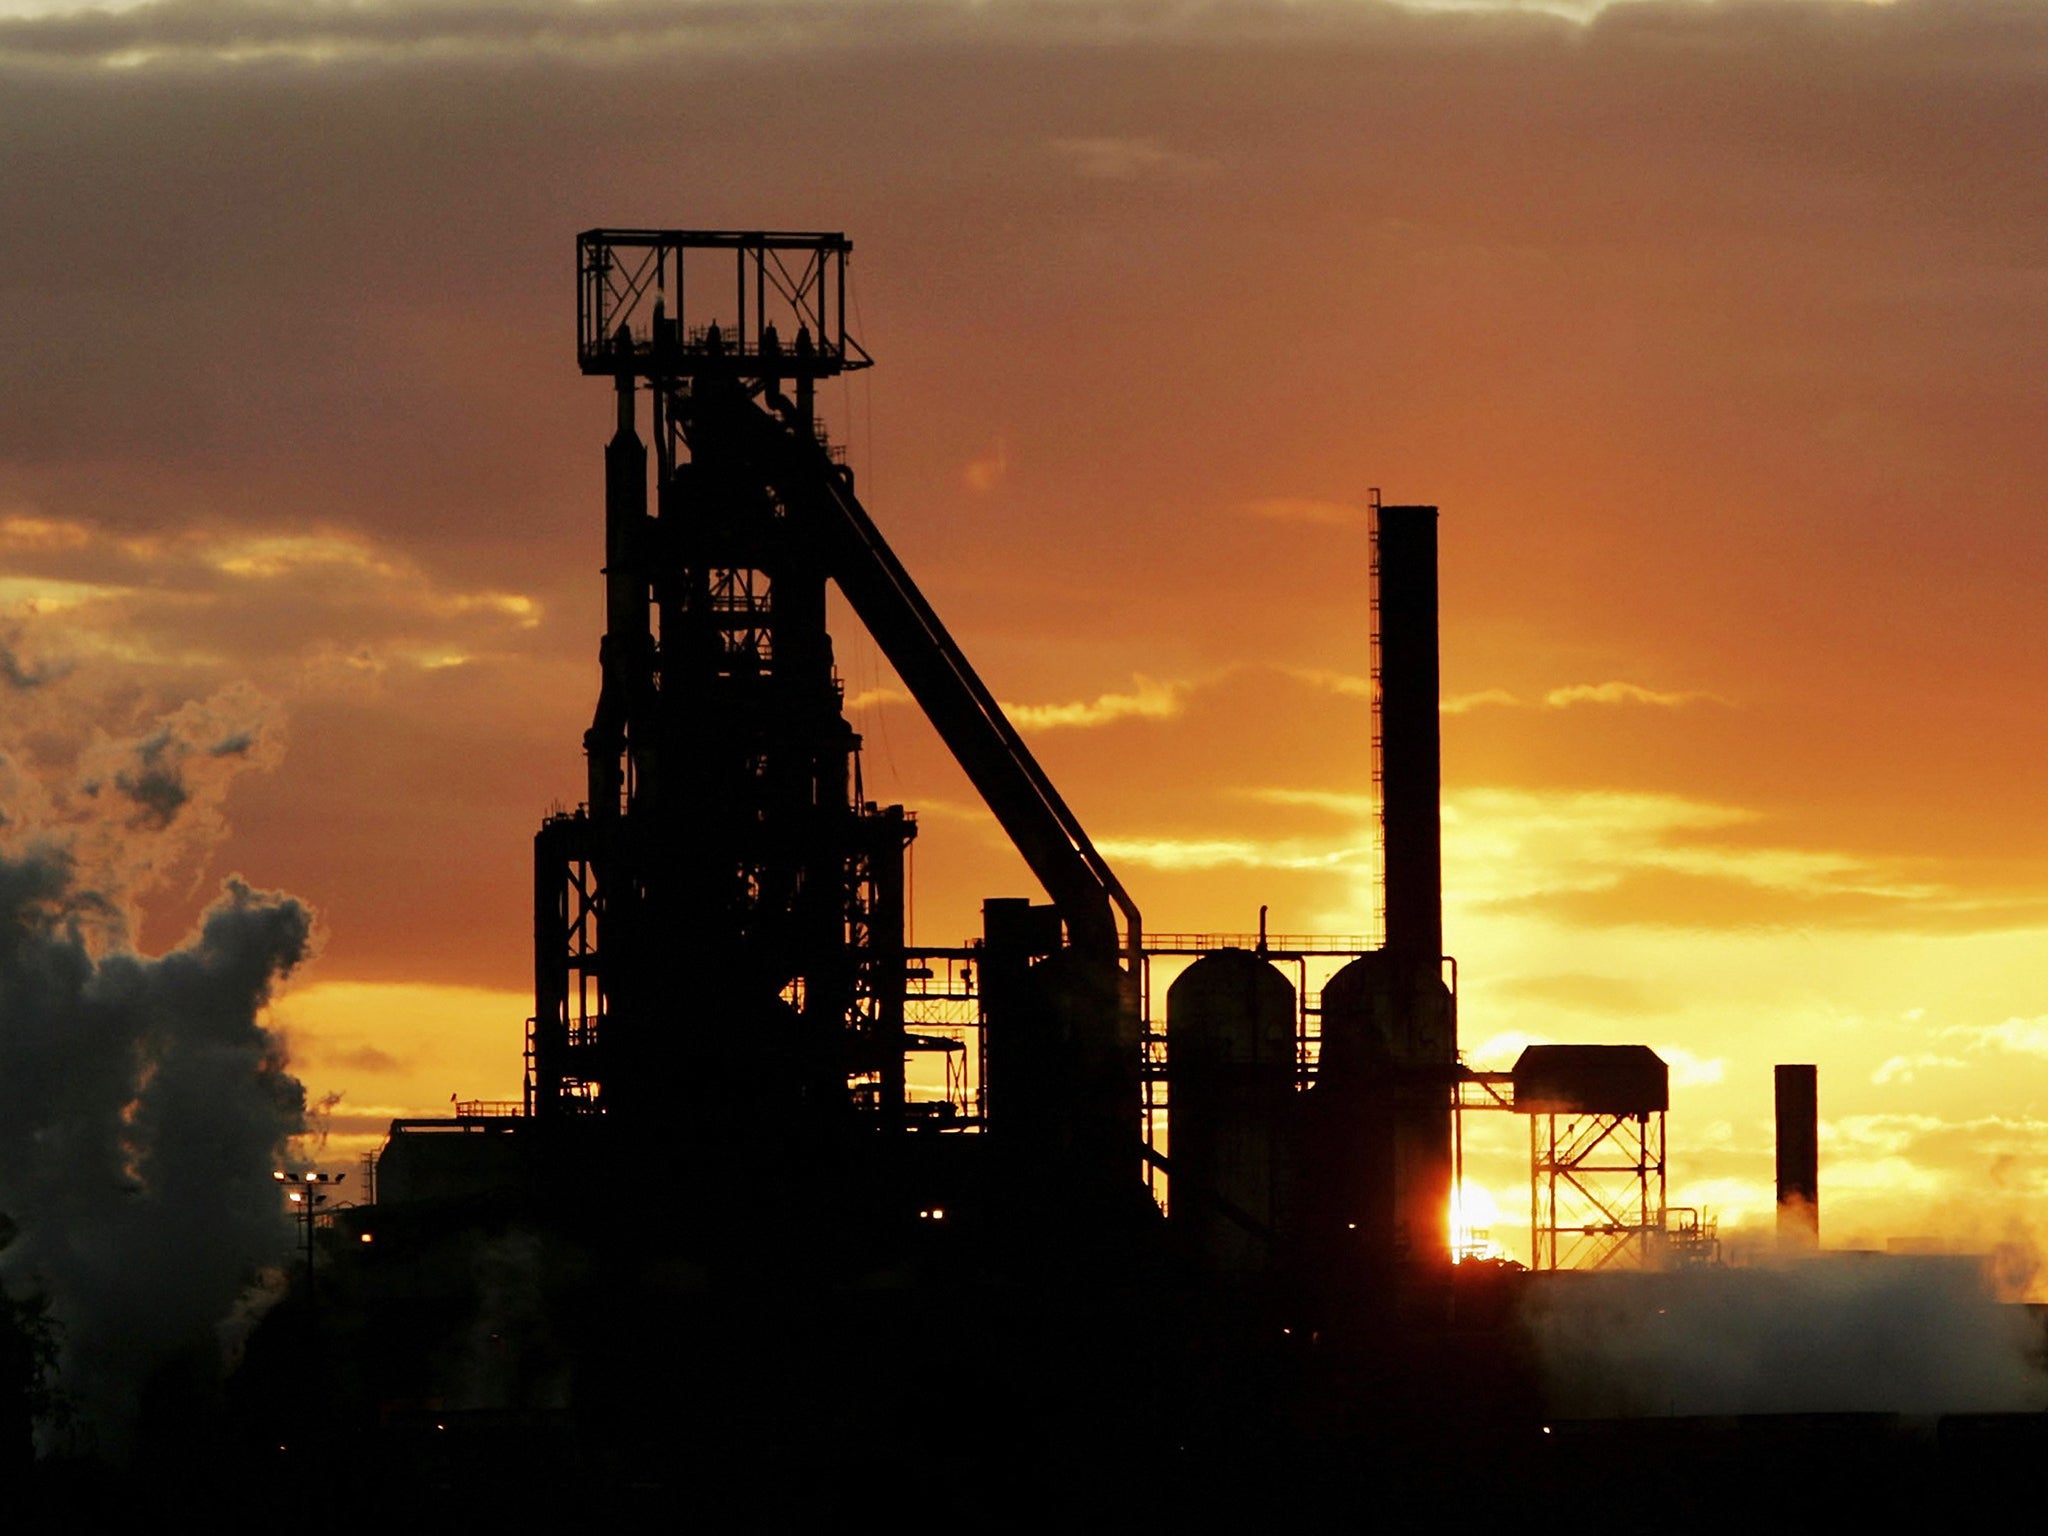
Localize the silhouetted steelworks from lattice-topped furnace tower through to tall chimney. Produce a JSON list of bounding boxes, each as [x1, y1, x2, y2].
[[383, 229, 1490, 1292]]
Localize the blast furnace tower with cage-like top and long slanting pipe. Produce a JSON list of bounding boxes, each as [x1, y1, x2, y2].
[[526, 229, 1143, 1212]]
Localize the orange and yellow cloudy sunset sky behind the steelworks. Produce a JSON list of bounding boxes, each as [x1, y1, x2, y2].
[[0, 0, 2048, 1255]]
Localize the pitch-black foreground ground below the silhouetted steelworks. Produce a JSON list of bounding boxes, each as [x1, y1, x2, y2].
[[12, 1210, 2048, 1532]]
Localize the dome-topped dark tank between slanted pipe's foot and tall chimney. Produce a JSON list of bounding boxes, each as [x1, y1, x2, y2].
[[1165, 948, 1298, 1278]]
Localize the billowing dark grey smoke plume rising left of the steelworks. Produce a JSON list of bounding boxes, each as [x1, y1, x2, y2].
[[0, 690, 311, 1448]]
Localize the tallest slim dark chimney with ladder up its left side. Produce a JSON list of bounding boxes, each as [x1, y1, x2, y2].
[[1378, 506, 1444, 975]]
